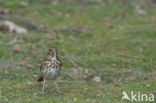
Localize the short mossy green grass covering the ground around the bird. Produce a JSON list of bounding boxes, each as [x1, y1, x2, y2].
[[0, 2, 156, 103]]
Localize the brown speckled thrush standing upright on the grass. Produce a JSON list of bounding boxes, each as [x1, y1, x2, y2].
[[38, 47, 62, 93]]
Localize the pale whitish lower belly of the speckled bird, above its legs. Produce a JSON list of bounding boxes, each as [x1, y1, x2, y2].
[[44, 68, 60, 80]]
